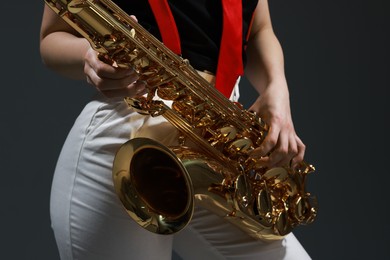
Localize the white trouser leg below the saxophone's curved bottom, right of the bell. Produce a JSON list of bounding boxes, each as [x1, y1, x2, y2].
[[173, 208, 311, 260]]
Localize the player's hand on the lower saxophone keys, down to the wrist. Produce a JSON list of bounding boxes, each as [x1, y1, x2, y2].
[[249, 82, 305, 167]]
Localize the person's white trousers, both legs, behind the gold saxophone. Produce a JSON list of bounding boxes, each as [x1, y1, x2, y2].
[[50, 94, 310, 260]]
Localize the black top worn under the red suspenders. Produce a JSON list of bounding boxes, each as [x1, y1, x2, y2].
[[114, 0, 258, 73]]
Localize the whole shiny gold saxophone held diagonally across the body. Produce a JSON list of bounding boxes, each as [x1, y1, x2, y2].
[[45, 0, 317, 240]]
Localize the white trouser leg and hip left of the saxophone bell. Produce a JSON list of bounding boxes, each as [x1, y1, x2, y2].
[[51, 98, 172, 260]]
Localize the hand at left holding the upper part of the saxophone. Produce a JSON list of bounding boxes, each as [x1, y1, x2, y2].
[[84, 48, 146, 98]]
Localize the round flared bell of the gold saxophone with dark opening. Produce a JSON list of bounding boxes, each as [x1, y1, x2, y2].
[[113, 138, 194, 234]]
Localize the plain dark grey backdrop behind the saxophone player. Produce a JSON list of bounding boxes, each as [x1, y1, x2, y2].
[[0, 0, 390, 259]]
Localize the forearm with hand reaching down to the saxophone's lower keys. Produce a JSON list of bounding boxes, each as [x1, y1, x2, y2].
[[246, 26, 305, 167]]
